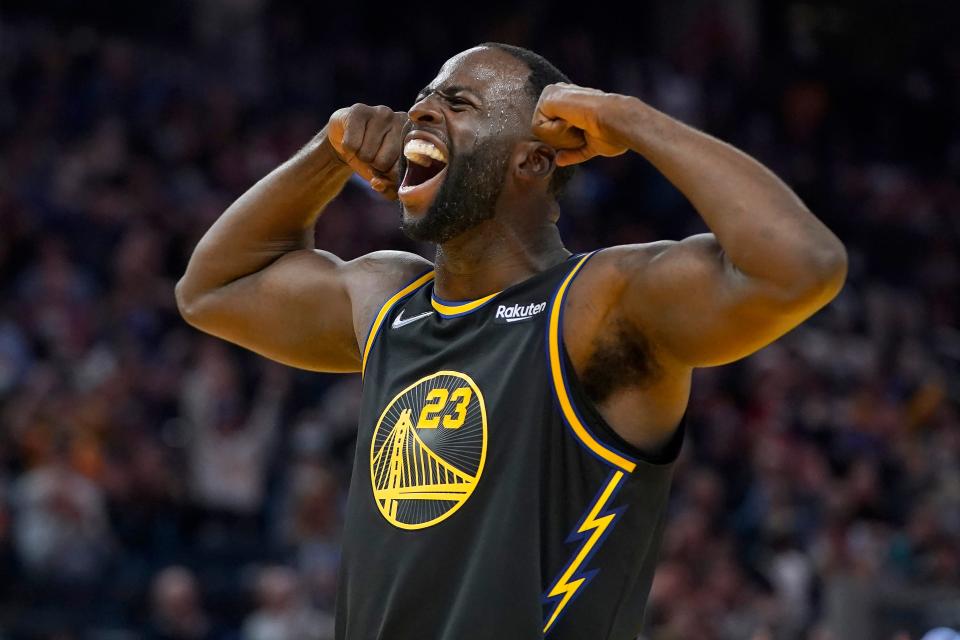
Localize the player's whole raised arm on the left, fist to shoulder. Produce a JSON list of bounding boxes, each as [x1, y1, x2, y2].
[[176, 105, 430, 372]]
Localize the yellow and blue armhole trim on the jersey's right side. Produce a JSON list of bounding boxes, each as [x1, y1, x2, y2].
[[547, 251, 637, 473]]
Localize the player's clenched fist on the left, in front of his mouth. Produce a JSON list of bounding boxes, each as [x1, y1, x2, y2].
[[327, 104, 408, 200]]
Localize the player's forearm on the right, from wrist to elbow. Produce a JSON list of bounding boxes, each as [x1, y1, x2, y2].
[[607, 97, 846, 291]]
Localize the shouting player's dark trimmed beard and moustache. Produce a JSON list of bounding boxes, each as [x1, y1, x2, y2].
[[400, 138, 510, 244]]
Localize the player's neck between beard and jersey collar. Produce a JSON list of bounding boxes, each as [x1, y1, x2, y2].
[[434, 208, 570, 300]]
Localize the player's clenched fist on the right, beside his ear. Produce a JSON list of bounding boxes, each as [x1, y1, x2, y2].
[[533, 82, 627, 167]]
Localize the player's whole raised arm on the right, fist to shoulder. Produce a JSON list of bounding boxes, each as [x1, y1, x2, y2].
[[533, 84, 847, 367]]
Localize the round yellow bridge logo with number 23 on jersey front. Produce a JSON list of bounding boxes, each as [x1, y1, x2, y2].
[[370, 371, 487, 529]]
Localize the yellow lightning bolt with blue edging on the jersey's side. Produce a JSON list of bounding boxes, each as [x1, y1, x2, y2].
[[543, 471, 625, 634]]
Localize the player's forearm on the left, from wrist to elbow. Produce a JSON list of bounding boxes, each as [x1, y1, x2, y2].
[[177, 129, 353, 302]]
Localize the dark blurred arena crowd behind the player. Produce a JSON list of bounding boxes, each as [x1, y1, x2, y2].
[[0, 0, 960, 640]]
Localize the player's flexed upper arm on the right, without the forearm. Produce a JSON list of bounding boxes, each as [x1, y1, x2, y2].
[[622, 233, 816, 367]]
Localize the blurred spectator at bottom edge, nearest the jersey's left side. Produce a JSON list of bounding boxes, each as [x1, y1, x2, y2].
[[243, 566, 334, 640]]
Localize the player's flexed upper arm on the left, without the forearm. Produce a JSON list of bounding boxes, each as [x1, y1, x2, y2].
[[180, 249, 360, 372]]
